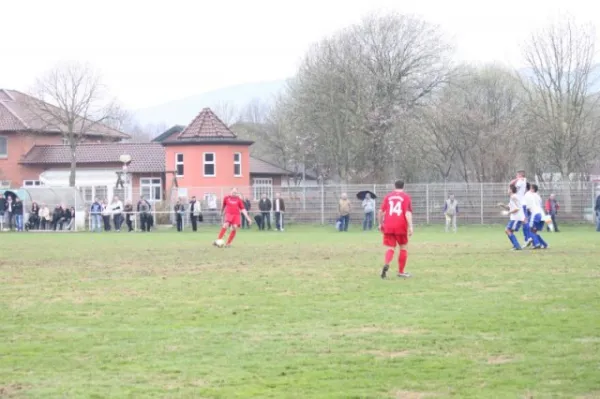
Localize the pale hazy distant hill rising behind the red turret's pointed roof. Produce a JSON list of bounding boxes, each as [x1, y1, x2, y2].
[[134, 80, 285, 126]]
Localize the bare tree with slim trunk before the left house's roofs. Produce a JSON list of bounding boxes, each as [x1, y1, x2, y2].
[[29, 63, 123, 187]]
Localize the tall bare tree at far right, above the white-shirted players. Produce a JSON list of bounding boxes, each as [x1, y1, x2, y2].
[[523, 18, 600, 181]]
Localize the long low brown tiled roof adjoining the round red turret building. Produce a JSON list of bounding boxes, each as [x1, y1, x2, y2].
[[21, 143, 165, 173]]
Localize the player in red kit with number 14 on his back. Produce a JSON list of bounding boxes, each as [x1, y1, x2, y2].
[[377, 180, 413, 278]]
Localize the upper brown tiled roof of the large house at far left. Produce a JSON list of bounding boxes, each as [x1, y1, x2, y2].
[[0, 89, 129, 139]]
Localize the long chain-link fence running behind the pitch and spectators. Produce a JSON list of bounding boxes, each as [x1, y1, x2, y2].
[[0, 182, 600, 230]]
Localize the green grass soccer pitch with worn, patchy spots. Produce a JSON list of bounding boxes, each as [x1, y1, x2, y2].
[[0, 226, 600, 398]]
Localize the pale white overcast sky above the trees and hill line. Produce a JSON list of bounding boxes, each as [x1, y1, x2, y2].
[[0, 0, 600, 109]]
